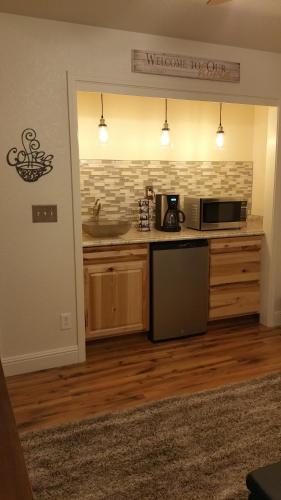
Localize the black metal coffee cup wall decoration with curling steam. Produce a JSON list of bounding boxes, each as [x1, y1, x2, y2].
[[7, 128, 54, 182]]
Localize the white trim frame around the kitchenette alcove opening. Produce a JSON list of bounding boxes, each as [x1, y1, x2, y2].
[[67, 73, 281, 361]]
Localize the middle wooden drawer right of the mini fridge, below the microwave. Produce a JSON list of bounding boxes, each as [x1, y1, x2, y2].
[[210, 250, 260, 286]]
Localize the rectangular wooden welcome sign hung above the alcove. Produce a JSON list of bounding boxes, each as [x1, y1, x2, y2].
[[132, 49, 240, 83]]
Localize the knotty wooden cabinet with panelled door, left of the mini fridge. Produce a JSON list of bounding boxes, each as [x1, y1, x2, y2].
[[84, 245, 148, 339]]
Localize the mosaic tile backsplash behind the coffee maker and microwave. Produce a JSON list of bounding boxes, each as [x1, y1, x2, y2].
[[80, 160, 253, 220]]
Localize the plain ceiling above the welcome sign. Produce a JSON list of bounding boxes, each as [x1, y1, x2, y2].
[[0, 0, 281, 52]]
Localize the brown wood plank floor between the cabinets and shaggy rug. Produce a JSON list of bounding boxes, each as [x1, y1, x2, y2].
[[7, 320, 281, 431]]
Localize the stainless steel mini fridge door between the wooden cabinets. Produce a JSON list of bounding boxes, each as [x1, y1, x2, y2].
[[150, 240, 209, 341]]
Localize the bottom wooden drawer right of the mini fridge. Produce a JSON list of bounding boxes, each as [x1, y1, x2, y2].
[[209, 281, 260, 319]]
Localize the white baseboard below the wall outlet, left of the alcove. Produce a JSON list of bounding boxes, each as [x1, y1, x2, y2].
[[2, 345, 79, 377]]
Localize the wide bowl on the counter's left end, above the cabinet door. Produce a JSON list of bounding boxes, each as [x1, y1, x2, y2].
[[82, 220, 131, 238]]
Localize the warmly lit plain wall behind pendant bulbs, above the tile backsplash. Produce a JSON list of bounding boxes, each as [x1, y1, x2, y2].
[[77, 92, 255, 161]]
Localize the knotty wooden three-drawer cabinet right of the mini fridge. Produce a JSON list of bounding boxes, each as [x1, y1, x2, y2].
[[209, 236, 262, 320]]
